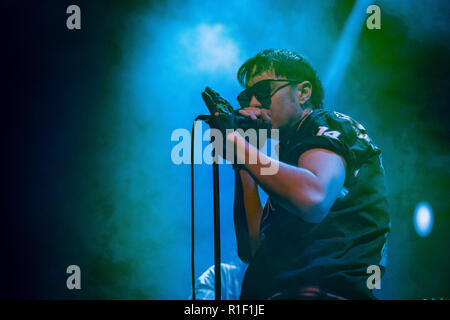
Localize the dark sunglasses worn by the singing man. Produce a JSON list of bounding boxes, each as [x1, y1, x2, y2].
[[237, 79, 301, 109]]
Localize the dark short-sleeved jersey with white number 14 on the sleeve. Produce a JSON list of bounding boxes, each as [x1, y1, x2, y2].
[[241, 109, 390, 299]]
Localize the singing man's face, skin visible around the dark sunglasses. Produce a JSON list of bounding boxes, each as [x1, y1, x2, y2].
[[244, 70, 301, 129]]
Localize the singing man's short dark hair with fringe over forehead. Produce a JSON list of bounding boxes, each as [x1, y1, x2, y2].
[[237, 49, 324, 108]]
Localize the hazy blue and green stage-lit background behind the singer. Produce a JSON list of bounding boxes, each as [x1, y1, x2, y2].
[[1, 0, 450, 299]]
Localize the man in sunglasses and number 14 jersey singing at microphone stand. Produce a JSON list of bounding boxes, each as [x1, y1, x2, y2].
[[204, 50, 390, 299]]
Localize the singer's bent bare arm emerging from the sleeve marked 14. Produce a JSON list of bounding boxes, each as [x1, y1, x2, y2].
[[227, 132, 345, 223]]
